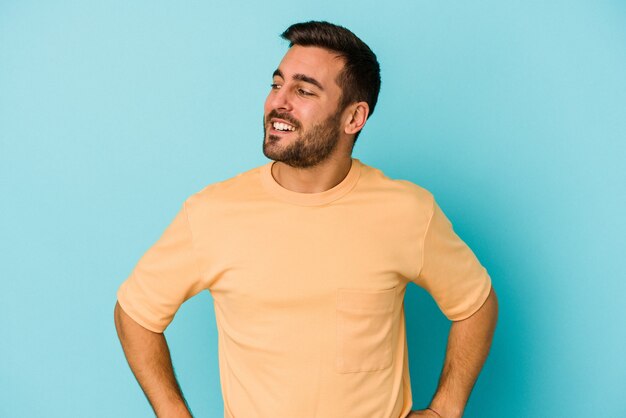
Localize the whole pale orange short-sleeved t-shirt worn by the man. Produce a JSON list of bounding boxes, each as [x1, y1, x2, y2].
[[118, 159, 491, 418]]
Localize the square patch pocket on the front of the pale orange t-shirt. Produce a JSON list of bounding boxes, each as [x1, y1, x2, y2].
[[335, 287, 396, 373]]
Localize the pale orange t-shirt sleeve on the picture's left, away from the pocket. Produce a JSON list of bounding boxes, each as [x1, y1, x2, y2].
[[117, 205, 205, 332]]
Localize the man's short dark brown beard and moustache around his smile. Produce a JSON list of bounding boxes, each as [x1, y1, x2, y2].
[[263, 110, 341, 168]]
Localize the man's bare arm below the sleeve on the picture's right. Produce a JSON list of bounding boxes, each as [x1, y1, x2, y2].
[[430, 289, 498, 418]]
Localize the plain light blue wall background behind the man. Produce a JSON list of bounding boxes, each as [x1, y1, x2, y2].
[[0, 0, 626, 418]]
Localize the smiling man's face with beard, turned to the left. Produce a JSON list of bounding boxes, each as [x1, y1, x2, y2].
[[263, 45, 344, 168]]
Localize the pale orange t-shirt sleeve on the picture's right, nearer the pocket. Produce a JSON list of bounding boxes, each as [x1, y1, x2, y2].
[[416, 203, 491, 321]]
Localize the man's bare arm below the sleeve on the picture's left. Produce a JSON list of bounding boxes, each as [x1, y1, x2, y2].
[[114, 303, 191, 418]]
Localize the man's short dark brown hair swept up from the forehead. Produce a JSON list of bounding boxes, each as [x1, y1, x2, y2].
[[281, 21, 380, 140]]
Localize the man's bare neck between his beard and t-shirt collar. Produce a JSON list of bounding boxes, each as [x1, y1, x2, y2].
[[272, 154, 352, 193]]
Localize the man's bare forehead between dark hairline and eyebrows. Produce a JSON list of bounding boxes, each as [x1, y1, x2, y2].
[[278, 45, 344, 88]]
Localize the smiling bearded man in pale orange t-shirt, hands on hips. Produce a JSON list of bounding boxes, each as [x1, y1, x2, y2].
[[115, 22, 497, 418]]
